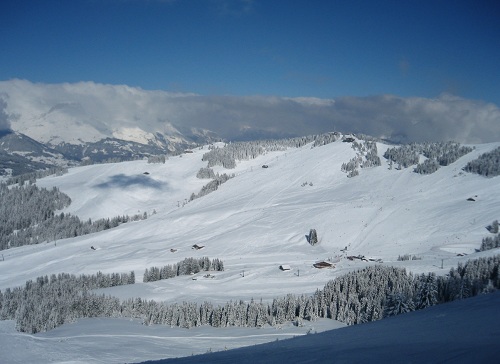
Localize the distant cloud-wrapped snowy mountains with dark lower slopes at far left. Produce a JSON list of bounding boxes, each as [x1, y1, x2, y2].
[[0, 80, 221, 176]]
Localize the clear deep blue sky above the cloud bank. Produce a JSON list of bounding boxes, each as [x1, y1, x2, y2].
[[0, 0, 500, 105]]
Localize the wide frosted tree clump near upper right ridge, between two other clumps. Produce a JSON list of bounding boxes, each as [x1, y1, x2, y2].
[[384, 142, 472, 174]]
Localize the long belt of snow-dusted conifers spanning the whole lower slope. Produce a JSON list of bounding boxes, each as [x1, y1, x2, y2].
[[0, 255, 500, 333]]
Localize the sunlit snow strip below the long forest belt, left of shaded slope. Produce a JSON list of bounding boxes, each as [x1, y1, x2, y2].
[[0, 318, 345, 364]]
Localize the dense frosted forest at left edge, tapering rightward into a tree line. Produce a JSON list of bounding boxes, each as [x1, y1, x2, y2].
[[0, 183, 147, 250]]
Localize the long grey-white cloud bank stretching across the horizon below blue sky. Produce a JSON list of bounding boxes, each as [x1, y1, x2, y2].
[[0, 80, 500, 143]]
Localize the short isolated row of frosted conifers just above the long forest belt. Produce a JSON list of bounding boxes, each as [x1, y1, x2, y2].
[[143, 257, 224, 282]]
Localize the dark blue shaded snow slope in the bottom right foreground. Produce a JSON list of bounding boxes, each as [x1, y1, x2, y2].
[[149, 292, 500, 364]]
